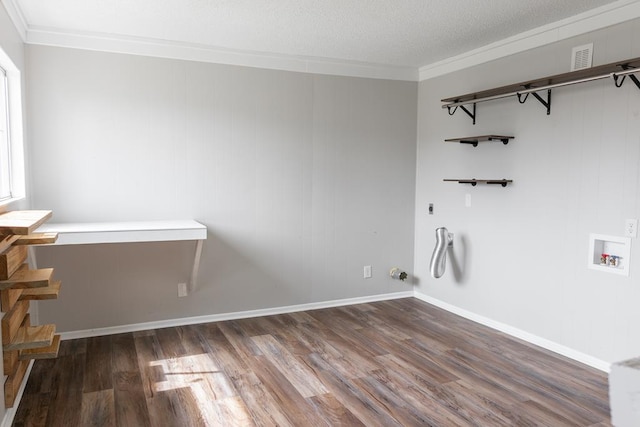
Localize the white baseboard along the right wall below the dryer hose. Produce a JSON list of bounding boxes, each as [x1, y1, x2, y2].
[[414, 291, 611, 373]]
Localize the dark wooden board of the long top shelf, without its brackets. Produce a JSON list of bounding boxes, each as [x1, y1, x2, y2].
[[442, 58, 640, 103]]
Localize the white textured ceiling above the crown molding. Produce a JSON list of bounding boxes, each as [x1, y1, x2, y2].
[[13, 0, 614, 67]]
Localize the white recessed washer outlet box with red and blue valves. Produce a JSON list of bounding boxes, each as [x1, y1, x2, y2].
[[587, 233, 631, 276]]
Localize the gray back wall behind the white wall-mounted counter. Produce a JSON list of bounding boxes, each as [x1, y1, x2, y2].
[[27, 45, 417, 331]]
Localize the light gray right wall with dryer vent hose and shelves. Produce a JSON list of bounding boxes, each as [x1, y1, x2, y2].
[[415, 16, 640, 362]]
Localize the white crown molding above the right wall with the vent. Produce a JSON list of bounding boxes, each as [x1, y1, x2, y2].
[[419, 0, 640, 81]]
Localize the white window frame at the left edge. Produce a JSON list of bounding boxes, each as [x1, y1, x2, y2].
[[0, 48, 26, 206]]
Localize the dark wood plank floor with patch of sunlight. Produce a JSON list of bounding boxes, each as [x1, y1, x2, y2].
[[14, 298, 611, 427]]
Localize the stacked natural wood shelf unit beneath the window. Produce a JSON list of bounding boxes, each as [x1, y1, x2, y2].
[[0, 211, 60, 408]]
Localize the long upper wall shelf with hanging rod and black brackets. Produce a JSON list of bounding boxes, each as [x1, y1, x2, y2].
[[441, 58, 640, 125]]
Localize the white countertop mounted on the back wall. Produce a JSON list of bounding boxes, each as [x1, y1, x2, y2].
[[38, 220, 207, 245]]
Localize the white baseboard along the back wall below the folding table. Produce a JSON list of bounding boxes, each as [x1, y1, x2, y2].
[[60, 291, 414, 340]]
